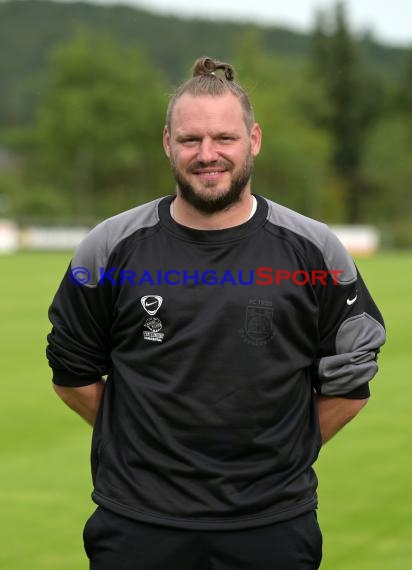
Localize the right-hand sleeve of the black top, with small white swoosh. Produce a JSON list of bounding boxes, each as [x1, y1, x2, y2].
[[314, 230, 386, 398]]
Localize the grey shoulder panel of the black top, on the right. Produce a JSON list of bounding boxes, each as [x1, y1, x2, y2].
[[266, 199, 357, 285]]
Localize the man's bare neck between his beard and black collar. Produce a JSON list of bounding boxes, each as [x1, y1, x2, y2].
[[172, 188, 254, 230]]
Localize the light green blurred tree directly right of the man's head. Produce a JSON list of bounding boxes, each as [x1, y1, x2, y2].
[[234, 28, 331, 218]]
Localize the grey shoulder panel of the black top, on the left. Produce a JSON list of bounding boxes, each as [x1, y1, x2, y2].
[[71, 198, 162, 287]]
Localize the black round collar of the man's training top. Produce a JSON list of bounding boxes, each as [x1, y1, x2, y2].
[[158, 194, 268, 243]]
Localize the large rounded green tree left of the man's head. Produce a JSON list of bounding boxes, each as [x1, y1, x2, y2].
[[19, 31, 168, 221]]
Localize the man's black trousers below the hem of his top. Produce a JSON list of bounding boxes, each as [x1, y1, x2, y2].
[[83, 507, 322, 570]]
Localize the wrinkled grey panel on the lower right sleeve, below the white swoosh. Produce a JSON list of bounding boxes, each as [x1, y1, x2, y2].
[[318, 313, 386, 396]]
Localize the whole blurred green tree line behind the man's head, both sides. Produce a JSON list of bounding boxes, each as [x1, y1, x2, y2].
[[0, 3, 412, 246]]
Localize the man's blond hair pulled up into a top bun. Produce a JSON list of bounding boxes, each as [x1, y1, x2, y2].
[[166, 57, 255, 132]]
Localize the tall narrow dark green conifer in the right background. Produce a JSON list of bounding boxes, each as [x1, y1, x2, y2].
[[312, 3, 383, 223]]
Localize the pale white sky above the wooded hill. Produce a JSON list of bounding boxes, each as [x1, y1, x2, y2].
[[72, 0, 412, 47]]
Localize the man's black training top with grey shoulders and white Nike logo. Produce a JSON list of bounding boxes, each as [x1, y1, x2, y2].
[[47, 196, 385, 529]]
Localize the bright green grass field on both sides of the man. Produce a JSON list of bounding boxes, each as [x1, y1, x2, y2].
[[0, 253, 412, 570]]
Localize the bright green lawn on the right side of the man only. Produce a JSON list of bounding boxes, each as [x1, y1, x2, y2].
[[317, 253, 412, 570]]
